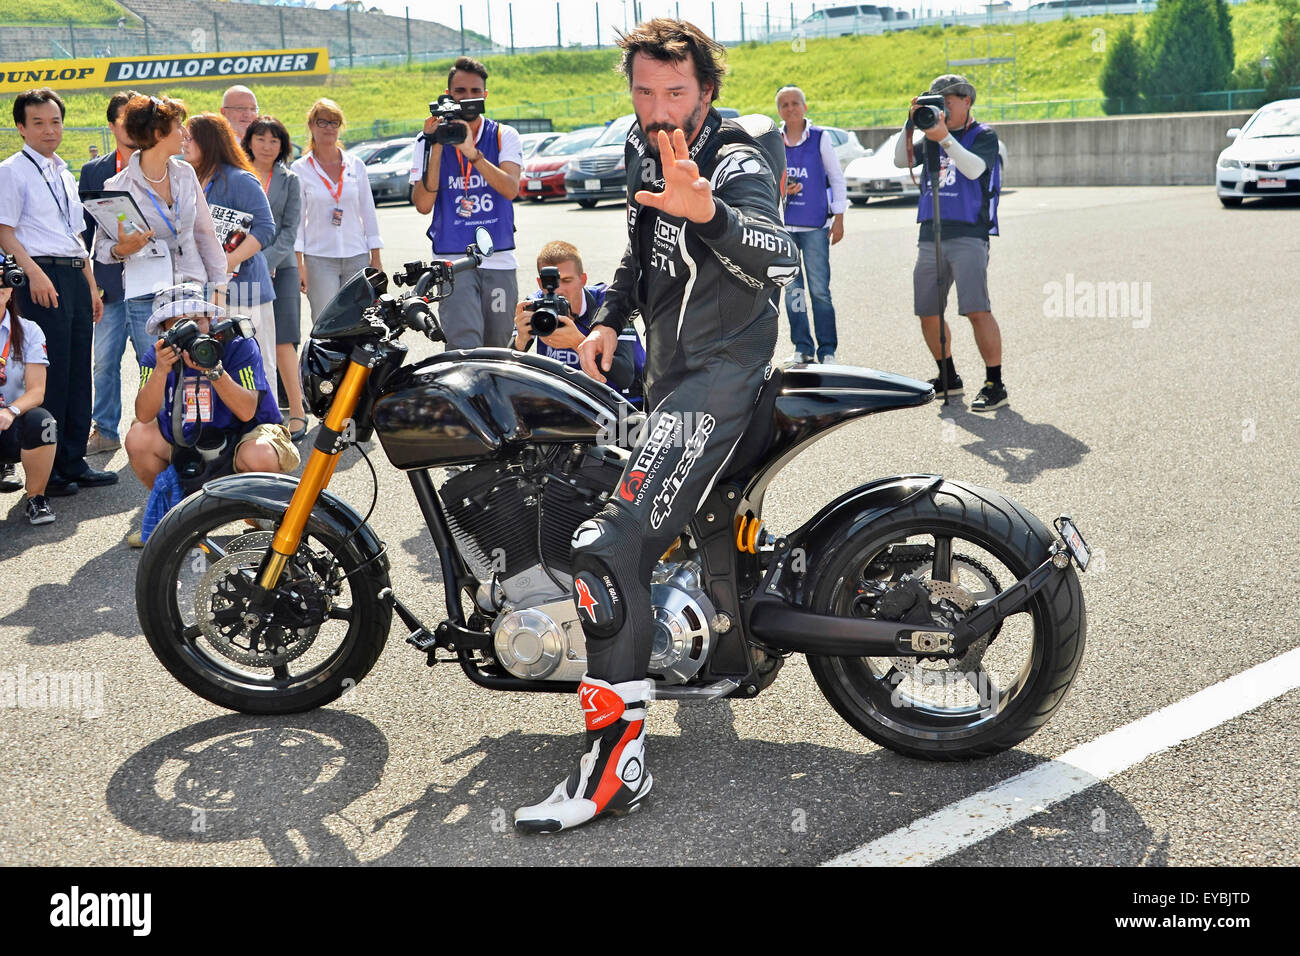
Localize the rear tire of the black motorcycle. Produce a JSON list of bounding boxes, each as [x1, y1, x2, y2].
[[807, 481, 1087, 761]]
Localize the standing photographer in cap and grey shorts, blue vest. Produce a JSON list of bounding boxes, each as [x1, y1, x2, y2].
[[894, 74, 1006, 411]]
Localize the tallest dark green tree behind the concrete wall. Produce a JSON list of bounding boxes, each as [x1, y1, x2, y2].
[[1141, 0, 1232, 109]]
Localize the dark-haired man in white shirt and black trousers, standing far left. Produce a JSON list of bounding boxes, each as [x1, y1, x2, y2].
[[0, 88, 117, 496]]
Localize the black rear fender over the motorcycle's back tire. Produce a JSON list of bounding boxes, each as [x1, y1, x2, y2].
[[777, 475, 944, 605]]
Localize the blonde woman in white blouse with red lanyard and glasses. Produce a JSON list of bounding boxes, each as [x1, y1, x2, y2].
[[291, 99, 384, 320]]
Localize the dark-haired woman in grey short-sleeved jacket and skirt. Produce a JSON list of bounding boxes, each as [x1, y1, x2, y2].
[[243, 116, 307, 441]]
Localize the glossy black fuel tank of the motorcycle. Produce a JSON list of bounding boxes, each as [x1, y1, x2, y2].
[[374, 349, 632, 468]]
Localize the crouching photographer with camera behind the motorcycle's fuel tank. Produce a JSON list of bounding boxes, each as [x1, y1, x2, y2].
[[514, 239, 646, 408]]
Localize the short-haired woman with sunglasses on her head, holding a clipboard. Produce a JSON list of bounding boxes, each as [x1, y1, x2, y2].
[[95, 96, 226, 348]]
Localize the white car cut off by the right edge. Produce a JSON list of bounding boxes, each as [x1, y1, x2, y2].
[[1214, 99, 1300, 208]]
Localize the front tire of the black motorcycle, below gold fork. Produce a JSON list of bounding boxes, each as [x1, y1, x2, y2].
[[135, 494, 393, 714]]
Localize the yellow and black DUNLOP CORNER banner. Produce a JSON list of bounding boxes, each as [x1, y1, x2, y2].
[[0, 48, 329, 92]]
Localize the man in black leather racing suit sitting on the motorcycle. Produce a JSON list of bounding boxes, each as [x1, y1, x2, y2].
[[515, 18, 798, 832]]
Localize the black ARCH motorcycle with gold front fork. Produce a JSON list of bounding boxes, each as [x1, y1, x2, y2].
[[135, 233, 1088, 760]]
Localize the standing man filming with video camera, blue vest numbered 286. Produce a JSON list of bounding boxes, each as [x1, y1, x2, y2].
[[411, 56, 524, 350]]
